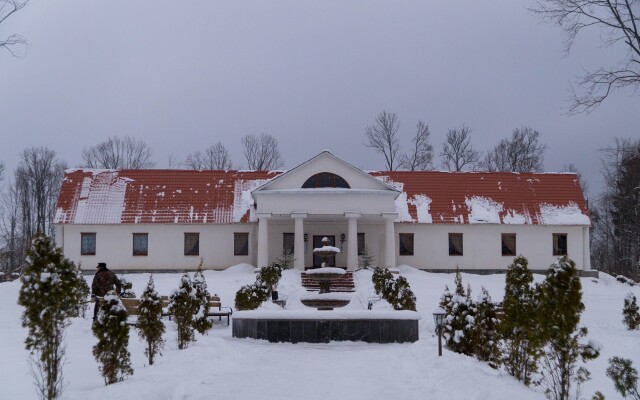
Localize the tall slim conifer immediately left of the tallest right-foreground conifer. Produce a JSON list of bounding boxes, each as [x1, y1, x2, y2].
[[499, 256, 542, 386]]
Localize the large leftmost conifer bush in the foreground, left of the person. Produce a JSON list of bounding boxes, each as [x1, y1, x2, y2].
[[18, 235, 86, 399]]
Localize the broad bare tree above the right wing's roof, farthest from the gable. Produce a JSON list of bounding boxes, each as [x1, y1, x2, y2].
[[480, 126, 547, 172]]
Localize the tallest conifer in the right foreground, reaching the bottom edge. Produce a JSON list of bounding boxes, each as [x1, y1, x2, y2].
[[538, 256, 600, 400]]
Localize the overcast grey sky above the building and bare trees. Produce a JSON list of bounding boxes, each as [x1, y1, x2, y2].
[[0, 0, 640, 196]]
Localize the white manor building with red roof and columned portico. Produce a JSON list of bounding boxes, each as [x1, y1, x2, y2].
[[54, 151, 590, 272]]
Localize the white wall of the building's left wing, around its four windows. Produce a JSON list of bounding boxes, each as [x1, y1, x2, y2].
[[57, 223, 256, 270]]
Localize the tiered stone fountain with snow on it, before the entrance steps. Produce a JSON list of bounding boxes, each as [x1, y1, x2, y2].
[[300, 237, 351, 310]]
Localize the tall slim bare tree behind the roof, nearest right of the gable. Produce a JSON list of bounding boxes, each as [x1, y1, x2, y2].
[[364, 110, 400, 171]]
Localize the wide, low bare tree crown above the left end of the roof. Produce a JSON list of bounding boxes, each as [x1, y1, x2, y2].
[[82, 136, 156, 169]]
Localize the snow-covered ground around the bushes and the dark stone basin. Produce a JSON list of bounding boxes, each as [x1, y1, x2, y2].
[[0, 265, 640, 400]]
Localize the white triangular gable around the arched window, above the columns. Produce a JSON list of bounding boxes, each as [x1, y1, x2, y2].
[[252, 150, 400, 198]]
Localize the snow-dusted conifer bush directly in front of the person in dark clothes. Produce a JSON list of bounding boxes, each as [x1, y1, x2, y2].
[[91, 291, 133, 385]]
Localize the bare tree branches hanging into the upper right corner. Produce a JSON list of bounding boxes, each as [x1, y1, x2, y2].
[[532, 0, 640, 113]]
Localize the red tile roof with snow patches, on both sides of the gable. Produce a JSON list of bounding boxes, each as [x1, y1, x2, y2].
[[54, 170, 589, 225]]
